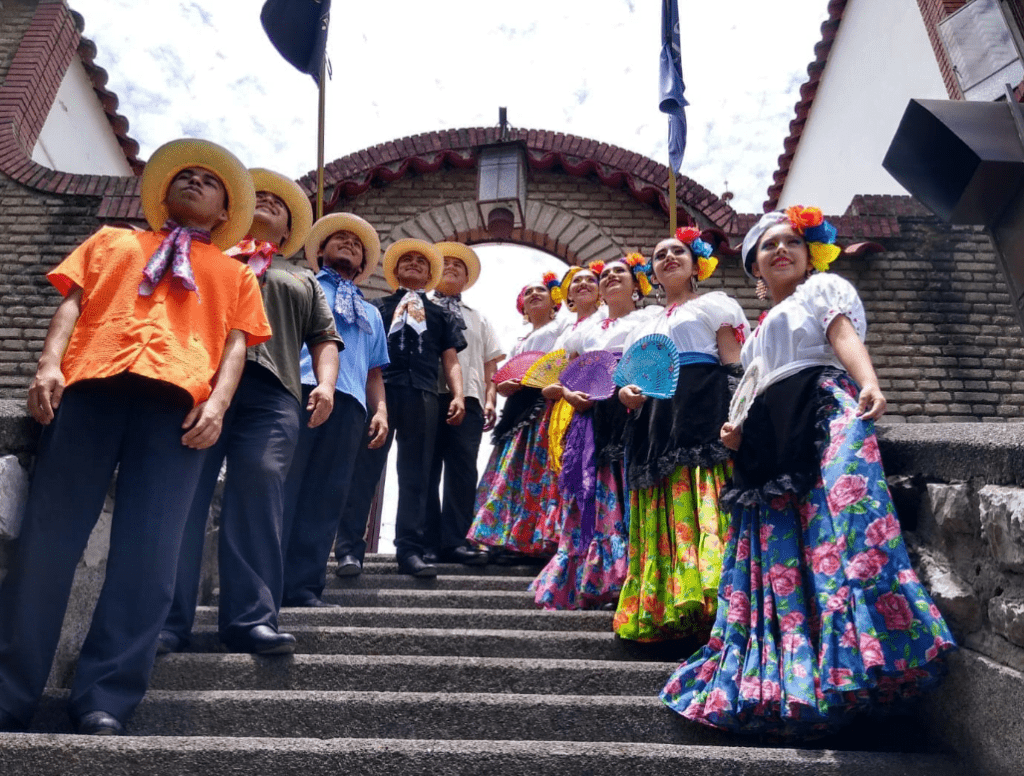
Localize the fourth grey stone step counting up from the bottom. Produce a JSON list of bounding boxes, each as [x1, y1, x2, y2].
[[180, 626, 690, 660]]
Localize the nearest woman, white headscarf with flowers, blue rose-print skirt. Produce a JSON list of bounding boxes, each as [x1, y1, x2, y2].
[[662, 207, 955, 736]]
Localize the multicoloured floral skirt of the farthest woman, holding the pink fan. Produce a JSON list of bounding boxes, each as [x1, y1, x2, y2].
[[467, 402, 561, 557]]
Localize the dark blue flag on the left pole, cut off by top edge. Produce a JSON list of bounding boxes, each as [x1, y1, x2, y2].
[[259, 0, 331, 85]]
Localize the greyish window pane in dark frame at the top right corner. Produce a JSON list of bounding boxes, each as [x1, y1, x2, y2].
[[939, 0, 1024, 100]]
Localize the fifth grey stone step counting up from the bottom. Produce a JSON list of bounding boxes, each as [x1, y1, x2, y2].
[[196, 606, 613, 632]]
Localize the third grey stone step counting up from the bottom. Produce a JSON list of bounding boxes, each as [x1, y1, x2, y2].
[[150, 653, 676, 696]]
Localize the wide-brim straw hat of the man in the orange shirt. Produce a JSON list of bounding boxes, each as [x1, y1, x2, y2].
[[141, 137, 256, 250]]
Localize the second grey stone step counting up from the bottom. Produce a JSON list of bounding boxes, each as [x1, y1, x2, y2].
[[19, 690, 749, 745]]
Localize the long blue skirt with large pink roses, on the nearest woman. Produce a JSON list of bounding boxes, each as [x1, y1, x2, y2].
[[662, 376, 955, 736]]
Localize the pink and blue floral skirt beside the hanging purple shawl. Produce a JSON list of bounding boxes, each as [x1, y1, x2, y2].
[[529, 463, 627, 609]]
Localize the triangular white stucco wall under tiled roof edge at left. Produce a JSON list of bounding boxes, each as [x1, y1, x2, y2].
[[32, 54, 132, 175]]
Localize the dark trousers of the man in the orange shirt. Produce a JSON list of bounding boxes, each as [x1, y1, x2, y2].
[[0, 375, 206, 724]]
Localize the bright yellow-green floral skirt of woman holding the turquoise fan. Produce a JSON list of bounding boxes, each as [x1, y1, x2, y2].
[[613, 463, 731, 641]]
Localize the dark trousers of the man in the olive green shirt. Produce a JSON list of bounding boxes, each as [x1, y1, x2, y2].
[[164, 362, 302, 639]]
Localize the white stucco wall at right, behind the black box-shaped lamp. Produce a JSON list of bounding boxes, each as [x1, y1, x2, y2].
[[779, 0, 948, 215]]
